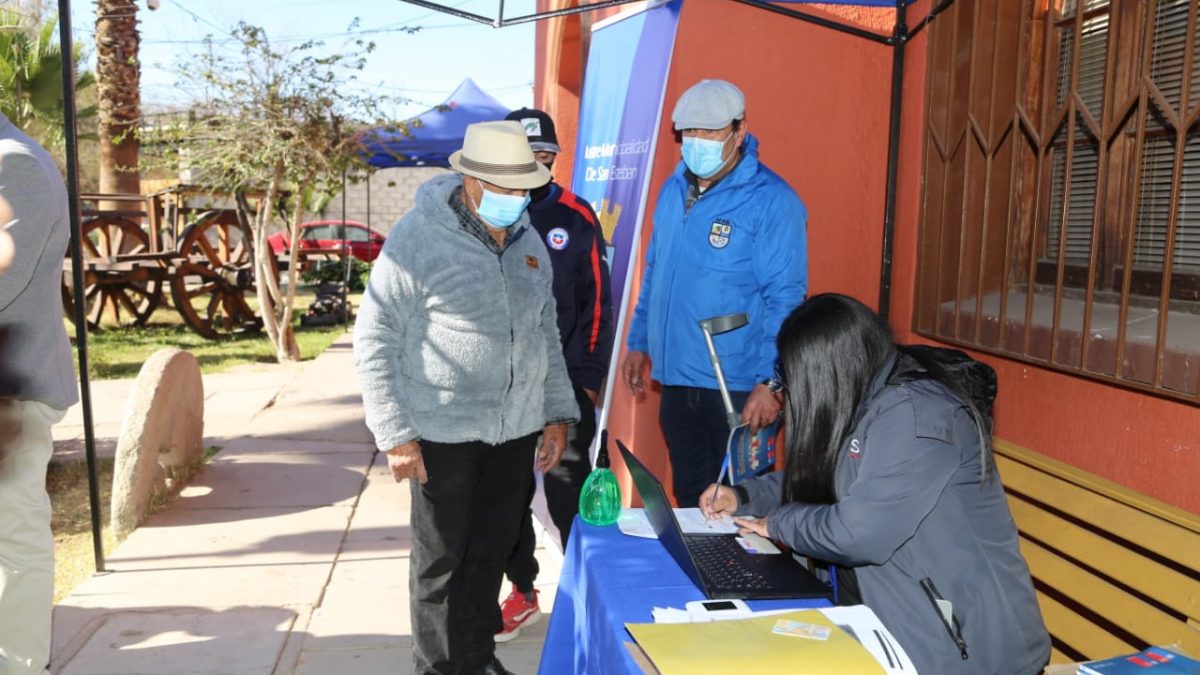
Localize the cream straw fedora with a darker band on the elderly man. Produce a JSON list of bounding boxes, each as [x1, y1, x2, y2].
[[450, 121, 550, 190]]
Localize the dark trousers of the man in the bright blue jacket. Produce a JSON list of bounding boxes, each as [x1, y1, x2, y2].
[[659, 387, 750, 508]]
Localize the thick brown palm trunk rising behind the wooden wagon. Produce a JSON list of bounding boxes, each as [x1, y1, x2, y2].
[[96, 0, 142, 195]]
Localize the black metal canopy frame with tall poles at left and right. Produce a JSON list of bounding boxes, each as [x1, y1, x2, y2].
[[59, 0, 954, 572]]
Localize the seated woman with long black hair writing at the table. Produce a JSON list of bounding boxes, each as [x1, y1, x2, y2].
[[701, 293, 1050, 675]]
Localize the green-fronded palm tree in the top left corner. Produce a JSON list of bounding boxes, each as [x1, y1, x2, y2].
[[0, 10, 96, 156]]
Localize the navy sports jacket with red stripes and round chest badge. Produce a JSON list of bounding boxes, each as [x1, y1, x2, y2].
[[529, 183, 613, 392]]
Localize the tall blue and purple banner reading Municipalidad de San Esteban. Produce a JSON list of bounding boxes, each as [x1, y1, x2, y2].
[[571, 0, 680, 460]]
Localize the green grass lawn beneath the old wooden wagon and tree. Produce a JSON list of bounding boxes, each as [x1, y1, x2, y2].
[[67, 286, 362, 380]]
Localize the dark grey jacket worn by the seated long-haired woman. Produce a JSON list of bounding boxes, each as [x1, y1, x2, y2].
[[738, 357, 1050, 675]]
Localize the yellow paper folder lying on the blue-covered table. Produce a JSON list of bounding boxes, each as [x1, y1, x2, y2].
[[625, 609, 884, 675]]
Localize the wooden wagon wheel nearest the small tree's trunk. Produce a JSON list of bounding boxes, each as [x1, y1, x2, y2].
[[170, 211, 263, 340]]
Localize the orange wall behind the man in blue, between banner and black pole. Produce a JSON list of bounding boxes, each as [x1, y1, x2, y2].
[[595, 0, 890, 494]]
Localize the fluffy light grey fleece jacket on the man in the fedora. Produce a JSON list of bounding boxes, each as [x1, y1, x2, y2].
[[354, 174, 580, 450]]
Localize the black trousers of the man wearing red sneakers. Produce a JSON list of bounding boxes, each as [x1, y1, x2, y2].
[[505, 387, 596, 593]]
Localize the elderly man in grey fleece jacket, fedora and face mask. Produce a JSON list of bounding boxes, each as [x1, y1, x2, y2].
[[354, 121, 580, 675]]
